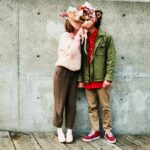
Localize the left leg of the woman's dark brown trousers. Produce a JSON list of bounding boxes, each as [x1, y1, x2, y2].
[[53, 67, 69, 128]]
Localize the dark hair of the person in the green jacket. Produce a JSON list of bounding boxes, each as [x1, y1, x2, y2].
[[94, 10, 103, 29]]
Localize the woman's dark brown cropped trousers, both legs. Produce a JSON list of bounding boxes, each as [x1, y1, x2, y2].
[[53, 66, 77, 129]]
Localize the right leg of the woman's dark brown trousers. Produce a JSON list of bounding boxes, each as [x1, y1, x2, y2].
[[65, 72, 77, 129]]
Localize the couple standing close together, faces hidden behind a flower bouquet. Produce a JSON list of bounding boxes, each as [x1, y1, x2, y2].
[[54, 2, 116, 143]]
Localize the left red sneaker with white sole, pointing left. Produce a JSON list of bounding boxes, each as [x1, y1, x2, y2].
[[83, 131, 100, 142]]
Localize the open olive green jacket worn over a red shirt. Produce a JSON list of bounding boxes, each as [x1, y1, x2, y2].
[[78, 31, 116, 83]]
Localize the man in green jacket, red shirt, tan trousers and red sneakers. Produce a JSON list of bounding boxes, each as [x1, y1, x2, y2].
[[78, 10, 116, 143]]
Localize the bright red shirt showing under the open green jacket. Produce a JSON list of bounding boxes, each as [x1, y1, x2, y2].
[[84, 29, 103, 89]]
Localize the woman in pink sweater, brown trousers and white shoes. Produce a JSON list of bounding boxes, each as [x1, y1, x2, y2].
[[53, 18, 83, 143]]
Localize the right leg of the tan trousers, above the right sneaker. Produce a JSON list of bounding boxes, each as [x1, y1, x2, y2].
[[97, 88, 112, 131]]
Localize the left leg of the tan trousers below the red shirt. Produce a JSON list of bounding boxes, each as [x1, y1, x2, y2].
[[85, 89, 99, 131]]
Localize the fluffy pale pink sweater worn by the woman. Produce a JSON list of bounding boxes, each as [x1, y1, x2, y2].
[[56, 32, 81, 71]]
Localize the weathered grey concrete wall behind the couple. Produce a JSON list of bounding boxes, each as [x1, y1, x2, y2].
[[0, 0, 150, 134]]
